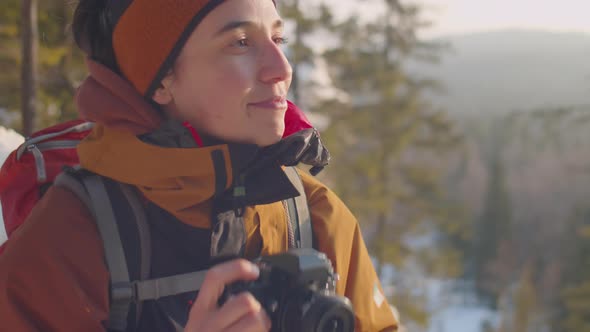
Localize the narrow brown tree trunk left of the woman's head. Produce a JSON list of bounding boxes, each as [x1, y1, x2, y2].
[[21, 0, 38, 136]]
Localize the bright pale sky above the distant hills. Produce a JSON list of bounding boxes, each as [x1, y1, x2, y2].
[[320, 0, 590, 37]]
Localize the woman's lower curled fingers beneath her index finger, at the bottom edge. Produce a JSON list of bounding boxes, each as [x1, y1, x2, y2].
[[211, 292, 271, 331]]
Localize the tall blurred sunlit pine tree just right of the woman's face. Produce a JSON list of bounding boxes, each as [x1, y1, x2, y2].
[[314, 0, 470, 324]]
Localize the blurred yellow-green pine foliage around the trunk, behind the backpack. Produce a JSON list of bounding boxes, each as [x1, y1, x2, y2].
[[0, 0, 86, 131]]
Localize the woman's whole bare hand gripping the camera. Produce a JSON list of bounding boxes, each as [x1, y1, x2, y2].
[[184, 259, 271, 332]]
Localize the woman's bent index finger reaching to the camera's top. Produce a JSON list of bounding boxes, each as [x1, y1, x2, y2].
[[189, 259, 260, 315]]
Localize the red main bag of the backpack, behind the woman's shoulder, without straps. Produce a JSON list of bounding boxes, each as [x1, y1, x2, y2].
[[0, 120, 93, 253]]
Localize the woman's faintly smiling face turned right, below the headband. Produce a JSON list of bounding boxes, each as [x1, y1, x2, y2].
[[154, 0, 292, 146]]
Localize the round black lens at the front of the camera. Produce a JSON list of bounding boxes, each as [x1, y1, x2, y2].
[[301, 294, 354, 332]]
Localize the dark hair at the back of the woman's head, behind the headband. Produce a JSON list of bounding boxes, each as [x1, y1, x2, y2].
[[72, 0, 120, 73]]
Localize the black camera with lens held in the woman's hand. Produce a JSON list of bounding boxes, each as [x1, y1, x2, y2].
[[220, 249, 354, 332]]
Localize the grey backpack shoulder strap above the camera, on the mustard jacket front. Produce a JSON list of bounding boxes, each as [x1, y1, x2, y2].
[[284, 167, 313, 249]]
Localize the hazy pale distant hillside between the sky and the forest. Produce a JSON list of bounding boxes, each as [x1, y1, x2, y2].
[[408, 30, 590, 114]]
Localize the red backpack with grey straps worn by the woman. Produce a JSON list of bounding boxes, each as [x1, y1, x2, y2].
[[0, 120, 313, 331]]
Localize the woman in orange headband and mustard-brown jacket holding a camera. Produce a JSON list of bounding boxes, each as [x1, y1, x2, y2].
[[0, 0, 397, 331]]
